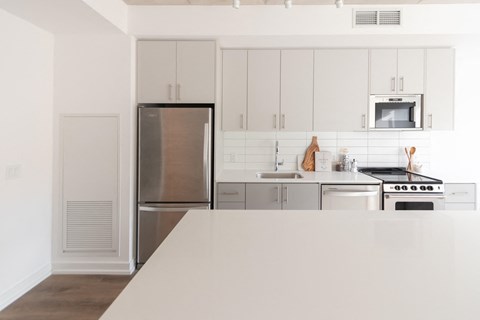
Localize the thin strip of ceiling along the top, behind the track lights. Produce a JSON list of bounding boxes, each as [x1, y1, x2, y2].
[[123, 0, 480, 6]]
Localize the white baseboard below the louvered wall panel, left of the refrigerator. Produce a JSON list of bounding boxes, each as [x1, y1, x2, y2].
[[52, 260, 135, 275]]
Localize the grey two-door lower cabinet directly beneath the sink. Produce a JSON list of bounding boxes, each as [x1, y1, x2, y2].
[[245, 183, 320, 210]]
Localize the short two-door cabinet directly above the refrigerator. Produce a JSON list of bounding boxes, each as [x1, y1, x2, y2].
[[137, 40, 215, 103]]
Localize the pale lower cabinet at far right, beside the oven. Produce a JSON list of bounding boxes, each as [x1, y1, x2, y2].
[[445, 183, 477, 210]]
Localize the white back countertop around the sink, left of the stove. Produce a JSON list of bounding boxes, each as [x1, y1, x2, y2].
[[216, 170, 381, 184]]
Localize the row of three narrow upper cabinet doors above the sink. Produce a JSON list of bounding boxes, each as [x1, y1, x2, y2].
[[222, 50, 314, 131]]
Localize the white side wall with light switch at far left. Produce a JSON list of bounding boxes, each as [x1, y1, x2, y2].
[[0, 10, 54, 310]]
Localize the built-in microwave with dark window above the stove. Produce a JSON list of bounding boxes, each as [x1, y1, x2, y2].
[[368, 94, 423, 130]]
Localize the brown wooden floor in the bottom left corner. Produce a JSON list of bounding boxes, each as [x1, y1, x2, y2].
[[0, 275, 133, 320]]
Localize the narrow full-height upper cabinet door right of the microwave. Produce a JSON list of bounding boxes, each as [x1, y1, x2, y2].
[[425, 49, 455, 130]]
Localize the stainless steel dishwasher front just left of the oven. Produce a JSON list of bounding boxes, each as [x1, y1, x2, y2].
[[321, 184, 382, 210]]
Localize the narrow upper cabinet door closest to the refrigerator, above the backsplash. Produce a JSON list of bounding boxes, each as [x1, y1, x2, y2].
[[222, 50, 247, 131]]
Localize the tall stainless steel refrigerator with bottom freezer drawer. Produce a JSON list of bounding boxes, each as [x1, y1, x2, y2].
[[137, 104, 213, 267]]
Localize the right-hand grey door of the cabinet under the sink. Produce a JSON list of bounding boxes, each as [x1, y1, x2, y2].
[[282, 183, 320, 210]]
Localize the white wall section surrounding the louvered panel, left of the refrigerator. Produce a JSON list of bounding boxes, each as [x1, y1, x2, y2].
[[53, 35, 135, 273]]
